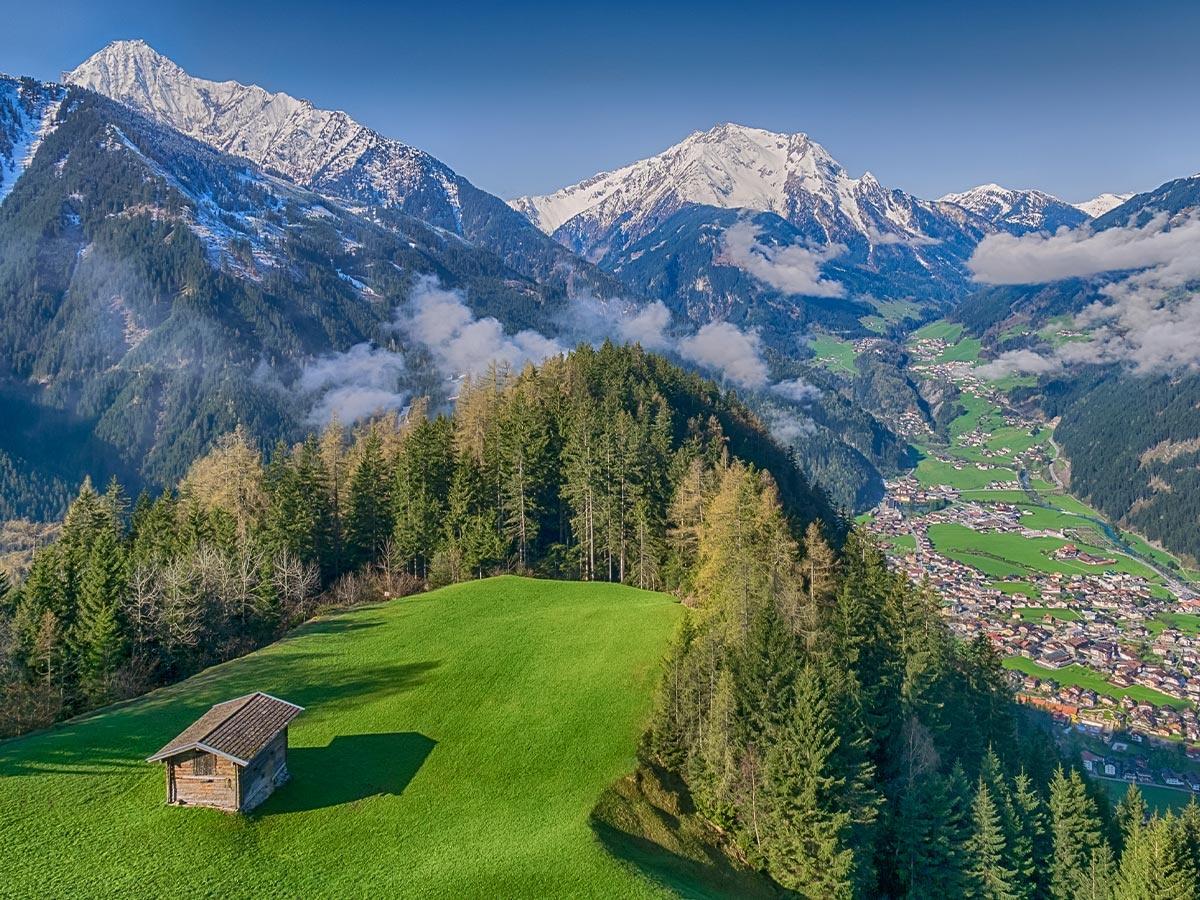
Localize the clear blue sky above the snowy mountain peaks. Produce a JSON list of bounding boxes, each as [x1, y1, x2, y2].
[[0, 0, 1200, 200]]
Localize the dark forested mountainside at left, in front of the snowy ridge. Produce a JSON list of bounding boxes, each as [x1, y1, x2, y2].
[[0, 77, 563, 514]]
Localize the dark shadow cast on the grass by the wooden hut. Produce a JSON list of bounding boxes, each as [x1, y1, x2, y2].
[[254, 731, 438, 816]]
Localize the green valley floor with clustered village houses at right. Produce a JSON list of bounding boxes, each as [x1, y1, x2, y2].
[[825, 323, 1200, 803]]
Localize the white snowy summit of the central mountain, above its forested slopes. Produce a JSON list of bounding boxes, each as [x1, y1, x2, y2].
[[510, 124, 979, 260]]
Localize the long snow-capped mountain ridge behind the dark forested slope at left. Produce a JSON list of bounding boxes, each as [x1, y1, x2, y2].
[[66, 41, 619, 295]]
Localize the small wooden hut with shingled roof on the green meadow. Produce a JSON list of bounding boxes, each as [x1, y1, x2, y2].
[[146, 691, 304, 812]]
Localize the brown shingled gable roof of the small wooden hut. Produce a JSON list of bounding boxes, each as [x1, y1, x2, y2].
[[146, 691, 304, 766]]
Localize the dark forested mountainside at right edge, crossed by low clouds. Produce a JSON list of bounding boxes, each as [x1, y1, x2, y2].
[[953, 170, 1200, 560]]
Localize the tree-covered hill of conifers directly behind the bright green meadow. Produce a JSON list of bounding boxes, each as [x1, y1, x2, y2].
[[0, 346, 839, 733]]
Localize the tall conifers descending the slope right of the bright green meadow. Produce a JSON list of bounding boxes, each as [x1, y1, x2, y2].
[[641, 461, 1200, 900]]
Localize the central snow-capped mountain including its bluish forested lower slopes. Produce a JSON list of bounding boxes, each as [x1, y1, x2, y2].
[[511, 124, 996, 340]]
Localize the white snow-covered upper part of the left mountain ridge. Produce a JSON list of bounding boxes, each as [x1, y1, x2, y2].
[[66, 41, 461, 228]]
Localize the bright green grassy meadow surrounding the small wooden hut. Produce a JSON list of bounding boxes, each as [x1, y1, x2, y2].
[[0, 577, 679, 896]]
